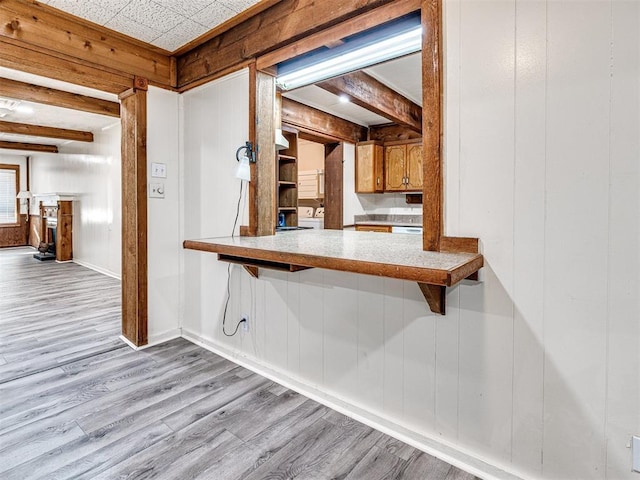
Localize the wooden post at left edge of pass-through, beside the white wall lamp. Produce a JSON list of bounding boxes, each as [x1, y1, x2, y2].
[[250, 69, 276, 236]]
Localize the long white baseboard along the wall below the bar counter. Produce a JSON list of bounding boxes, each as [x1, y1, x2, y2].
[[182, 328, 522, 480]]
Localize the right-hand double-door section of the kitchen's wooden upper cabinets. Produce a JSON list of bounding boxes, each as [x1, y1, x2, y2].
[[384, 140, 423, 192]]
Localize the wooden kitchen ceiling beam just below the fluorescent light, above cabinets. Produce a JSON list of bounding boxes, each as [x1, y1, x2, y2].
[[316, 71, 422, 133]]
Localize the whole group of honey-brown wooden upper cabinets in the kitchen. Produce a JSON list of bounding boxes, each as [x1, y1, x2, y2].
[[356, 139, 423, 193]]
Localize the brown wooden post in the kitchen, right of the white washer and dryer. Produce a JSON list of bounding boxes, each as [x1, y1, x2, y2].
[[324, 143, 344, 230]]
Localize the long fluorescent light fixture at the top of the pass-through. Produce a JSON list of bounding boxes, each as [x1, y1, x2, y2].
[[276, 13, 422, 90]]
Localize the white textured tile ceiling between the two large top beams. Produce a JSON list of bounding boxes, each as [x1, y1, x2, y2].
[[40, 0, 259, 52]]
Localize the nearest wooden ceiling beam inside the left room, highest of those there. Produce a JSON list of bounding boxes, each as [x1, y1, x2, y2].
[[0, 78, 120, 117]]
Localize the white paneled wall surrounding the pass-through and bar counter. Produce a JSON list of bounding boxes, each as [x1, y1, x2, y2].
[[183, 0, 640, 480]]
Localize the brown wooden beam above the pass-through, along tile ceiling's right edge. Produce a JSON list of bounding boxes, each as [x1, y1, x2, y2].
[[178, 0, 419, 88]]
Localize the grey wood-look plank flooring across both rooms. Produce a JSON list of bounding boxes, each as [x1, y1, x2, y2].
[[0, 249, 475, 480]]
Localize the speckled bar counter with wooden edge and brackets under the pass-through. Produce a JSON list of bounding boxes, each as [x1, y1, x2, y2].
[[183, 230, 484, 315]]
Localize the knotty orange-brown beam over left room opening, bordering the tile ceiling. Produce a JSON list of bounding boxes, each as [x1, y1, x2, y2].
[[0, 0, 174, 91]]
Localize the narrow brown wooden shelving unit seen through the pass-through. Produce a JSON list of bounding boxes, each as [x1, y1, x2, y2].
[[276, 129, 298, 227]]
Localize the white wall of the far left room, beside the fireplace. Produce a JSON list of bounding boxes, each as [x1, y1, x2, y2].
[[31, 124, 122, 278]]
